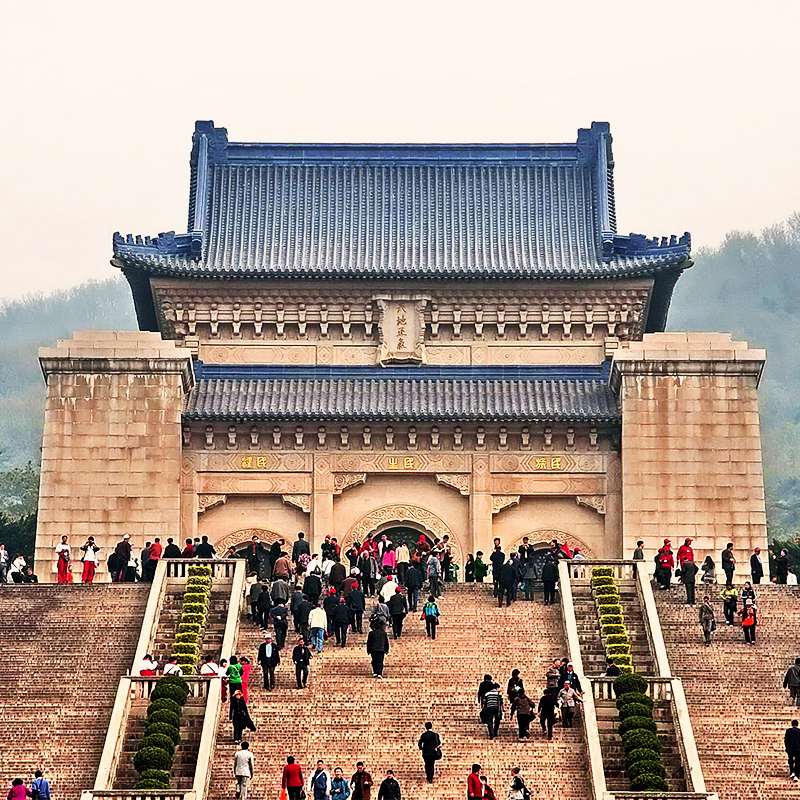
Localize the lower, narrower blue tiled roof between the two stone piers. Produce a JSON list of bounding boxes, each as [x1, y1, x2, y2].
[[184, 365, 619, 422]]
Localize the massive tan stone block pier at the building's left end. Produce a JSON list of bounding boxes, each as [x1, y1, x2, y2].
[[36, 331, 194, 582]]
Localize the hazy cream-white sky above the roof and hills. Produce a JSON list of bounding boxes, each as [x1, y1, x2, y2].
[[0, 0, 800, 298]]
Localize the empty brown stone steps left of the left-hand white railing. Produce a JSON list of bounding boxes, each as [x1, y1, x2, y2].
[[0, 584, 150, 800]]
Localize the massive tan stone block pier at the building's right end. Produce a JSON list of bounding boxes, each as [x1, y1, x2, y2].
[[612, 333, 767, 578]]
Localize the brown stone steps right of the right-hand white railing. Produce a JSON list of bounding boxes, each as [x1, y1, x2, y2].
[[656, 585, 800, 800]]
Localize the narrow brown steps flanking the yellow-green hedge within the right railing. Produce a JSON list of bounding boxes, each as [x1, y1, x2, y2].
[[572, 580, 655, 677]]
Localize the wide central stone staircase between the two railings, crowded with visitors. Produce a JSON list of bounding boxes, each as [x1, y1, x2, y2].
[[210, 584, 590, 800]]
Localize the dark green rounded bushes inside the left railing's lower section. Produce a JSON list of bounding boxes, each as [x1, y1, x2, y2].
[[133, 675, 189, 789]]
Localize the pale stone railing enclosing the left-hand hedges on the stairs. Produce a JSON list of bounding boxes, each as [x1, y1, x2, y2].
[[81, 559, 246, 800]]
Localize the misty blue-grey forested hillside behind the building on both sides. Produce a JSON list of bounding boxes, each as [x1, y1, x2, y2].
[[0, 214, 800, 535]]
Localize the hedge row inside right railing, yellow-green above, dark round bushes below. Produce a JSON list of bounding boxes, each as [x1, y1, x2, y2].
[[592, 567, 668, 792]]
